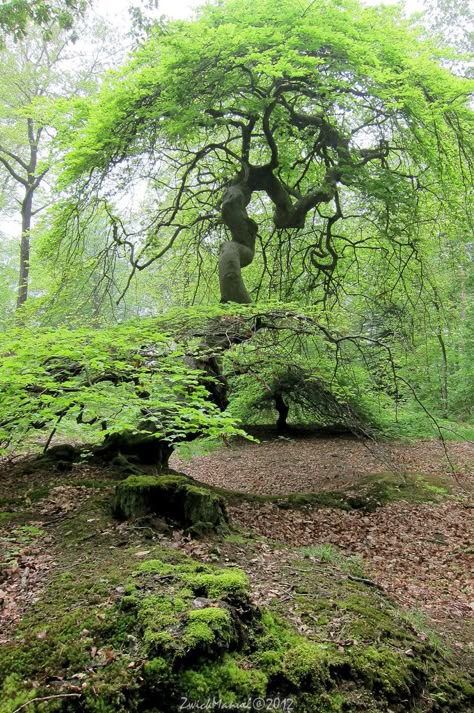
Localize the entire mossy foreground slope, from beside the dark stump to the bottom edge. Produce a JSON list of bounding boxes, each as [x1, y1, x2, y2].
[[0, 458, 474, 713]]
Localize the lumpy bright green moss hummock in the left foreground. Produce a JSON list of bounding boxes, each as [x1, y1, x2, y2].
[[0, 551, 251, 713]]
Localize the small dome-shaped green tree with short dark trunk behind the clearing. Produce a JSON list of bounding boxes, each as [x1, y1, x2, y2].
[[226, 336, 388, 435]]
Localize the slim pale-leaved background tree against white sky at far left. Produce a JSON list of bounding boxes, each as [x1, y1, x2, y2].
[[0, 18, 124, 308]]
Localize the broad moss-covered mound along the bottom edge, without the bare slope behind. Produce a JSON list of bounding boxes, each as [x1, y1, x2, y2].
[[0, 548, 474, 713]]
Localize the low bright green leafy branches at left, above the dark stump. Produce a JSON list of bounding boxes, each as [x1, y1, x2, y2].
[[0, 320, 241, 448]]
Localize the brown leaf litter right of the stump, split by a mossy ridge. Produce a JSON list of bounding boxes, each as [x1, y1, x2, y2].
[[171, 431, 474, 654]]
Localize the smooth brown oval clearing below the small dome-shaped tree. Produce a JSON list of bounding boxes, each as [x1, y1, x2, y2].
[[170, 437, 474, 495]]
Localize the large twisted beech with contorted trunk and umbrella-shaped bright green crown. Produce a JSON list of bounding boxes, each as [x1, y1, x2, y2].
[[58, 0, 474, 303]]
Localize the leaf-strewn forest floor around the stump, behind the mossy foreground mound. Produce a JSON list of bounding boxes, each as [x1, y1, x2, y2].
[[0, 432, 474, 710]]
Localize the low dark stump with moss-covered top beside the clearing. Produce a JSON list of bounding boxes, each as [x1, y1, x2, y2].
[[112, 474, 228, 535]]
